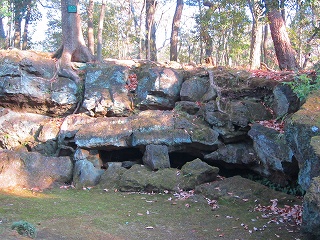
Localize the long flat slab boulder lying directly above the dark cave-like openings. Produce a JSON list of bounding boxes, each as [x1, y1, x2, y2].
[[75, 110, 219, 154]]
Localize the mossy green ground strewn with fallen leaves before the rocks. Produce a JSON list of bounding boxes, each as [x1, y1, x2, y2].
[[0, 189, 307, 240]]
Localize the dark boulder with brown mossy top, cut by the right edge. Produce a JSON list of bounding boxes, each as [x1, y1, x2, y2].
[[285, 91, 320, 190]]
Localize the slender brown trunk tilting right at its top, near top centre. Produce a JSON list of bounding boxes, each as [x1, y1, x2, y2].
[[170, 0, 183, 61]]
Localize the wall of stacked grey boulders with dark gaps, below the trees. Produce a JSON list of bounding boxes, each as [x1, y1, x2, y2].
[[0, 50, 320, 236]]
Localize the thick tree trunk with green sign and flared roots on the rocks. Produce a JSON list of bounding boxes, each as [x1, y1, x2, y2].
[[53, 0, 94, 82]]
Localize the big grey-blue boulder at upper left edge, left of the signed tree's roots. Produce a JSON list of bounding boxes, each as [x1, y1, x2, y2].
[[0, 49, 80, 116]]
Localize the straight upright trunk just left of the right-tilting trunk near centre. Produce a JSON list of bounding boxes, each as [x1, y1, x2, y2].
[[146, 0, 157, 61]]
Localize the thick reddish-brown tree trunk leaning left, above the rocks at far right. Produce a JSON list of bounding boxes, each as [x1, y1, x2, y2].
[[266, 0, 299, 70]]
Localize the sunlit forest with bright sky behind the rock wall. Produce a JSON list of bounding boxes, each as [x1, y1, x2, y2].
[[0, 0, 320, 69]]
